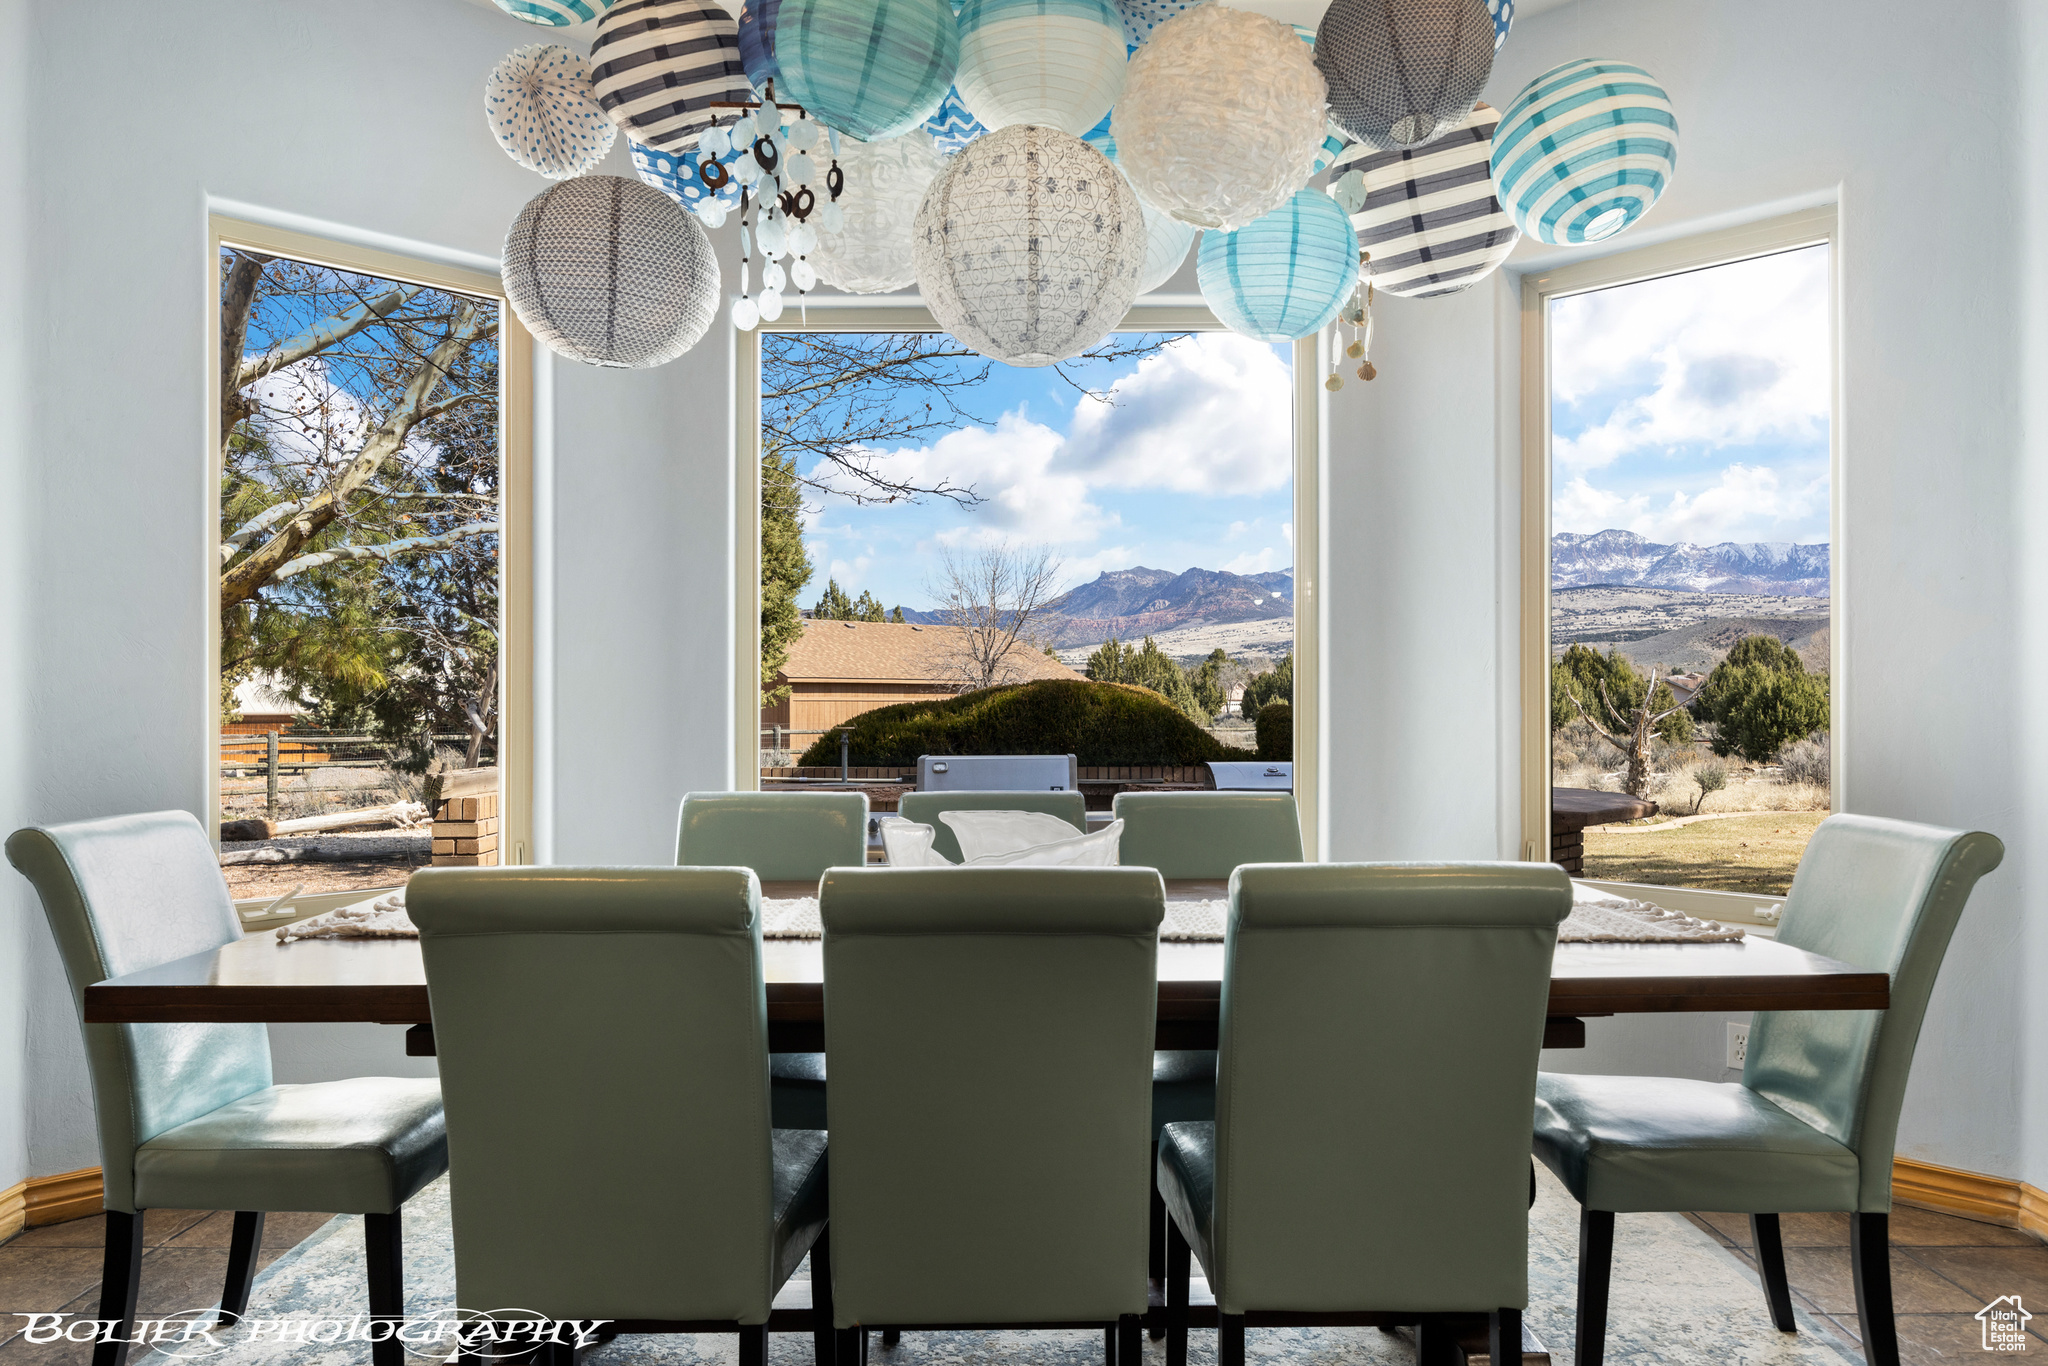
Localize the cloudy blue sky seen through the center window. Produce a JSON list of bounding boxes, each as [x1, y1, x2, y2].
[[803, 332, 1294, 608]]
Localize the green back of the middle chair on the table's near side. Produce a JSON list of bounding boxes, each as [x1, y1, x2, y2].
[[819, 868, 1165, 1327]]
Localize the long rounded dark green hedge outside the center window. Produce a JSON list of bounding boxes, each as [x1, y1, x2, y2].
[[797, 678, 1255, 766]]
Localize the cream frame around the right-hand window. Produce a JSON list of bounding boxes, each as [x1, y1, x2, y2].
[[1520, 205, 1849, 926]]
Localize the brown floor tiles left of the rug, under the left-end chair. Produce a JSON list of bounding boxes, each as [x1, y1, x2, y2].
[[0, 1210, 334, 1366]]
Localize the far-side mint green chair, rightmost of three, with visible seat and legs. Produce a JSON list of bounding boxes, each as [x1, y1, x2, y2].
[[1110, 793, 1300, 1337]]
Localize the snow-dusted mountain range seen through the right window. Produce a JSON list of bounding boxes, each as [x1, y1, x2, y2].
[[1550, 528, 1827, 598]]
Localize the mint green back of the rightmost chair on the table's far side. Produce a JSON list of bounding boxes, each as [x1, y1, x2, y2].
[[1112, 793, 1300, 879]]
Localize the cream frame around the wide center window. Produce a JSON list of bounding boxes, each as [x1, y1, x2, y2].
[[731, 305, 1327, 862]]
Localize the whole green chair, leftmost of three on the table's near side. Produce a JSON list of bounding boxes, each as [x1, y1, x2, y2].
[[406, 868, 831, 1366]]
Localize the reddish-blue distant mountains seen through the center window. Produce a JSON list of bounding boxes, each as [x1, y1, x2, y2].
[[903, 565, 1294, 647]]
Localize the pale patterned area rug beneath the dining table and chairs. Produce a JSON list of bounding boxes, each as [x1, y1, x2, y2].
[[131, 1171, 1862, 1366]]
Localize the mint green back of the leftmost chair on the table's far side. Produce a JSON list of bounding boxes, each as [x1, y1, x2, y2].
[[676, 793, 868, 883]]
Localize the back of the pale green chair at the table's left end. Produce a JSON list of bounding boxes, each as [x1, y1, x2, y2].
[[6, 811, 270, 1212]]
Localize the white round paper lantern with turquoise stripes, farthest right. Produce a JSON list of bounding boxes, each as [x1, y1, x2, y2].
[[1493, 57, 1677, 246]]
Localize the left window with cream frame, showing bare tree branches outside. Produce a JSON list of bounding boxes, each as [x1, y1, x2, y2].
[[215, 225, 526, 909]]
